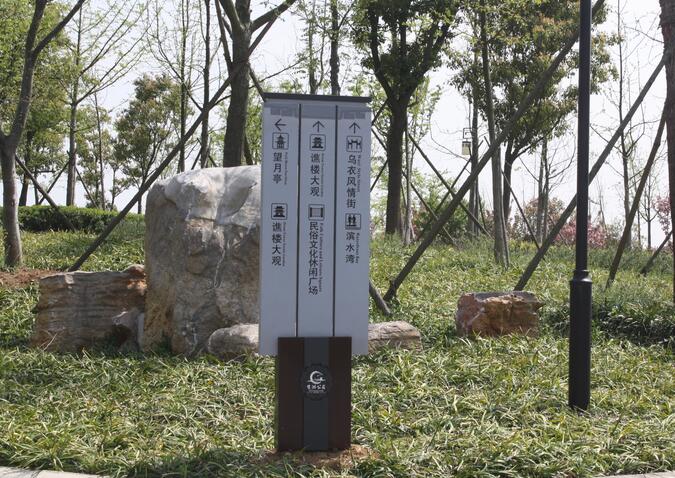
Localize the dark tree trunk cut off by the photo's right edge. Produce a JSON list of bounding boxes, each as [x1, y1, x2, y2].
[[659, 0, 675, 302]]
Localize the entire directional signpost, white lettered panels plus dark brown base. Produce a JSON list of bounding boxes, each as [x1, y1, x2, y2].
[[260, 93, 371, 451]]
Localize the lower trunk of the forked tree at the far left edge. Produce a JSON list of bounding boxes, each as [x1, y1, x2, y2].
[[0, 142, 23, 267]]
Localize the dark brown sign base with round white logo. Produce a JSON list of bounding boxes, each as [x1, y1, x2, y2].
[[275, 337, 352, 452]]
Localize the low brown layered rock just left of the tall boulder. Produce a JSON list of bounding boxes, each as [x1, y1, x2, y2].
[[30, 265, 146, 352]]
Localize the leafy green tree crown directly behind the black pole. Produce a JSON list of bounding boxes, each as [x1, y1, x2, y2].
[[452, 0, 614, 218]]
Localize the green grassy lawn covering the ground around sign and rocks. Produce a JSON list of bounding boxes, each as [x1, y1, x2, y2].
[[0, 227, 675, 477]]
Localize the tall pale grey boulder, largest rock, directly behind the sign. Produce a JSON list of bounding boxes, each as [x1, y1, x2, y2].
[[142, 166, 260, 355]]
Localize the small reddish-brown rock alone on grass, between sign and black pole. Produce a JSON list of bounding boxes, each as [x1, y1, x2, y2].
[[455, 291, 544, 337]]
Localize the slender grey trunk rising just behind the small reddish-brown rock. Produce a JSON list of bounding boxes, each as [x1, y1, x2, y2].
[[480, 0, 509, 267]]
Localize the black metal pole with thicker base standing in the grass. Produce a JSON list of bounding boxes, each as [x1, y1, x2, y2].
[[569, 0, 593, 410]]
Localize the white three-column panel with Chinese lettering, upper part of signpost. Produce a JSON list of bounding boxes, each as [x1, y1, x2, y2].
[[260, 94, 370, 355]]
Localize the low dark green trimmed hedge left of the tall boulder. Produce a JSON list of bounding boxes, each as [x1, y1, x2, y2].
[[1, 206, 143, 233]]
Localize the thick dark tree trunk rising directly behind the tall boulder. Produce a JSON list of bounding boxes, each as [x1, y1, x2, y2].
[[223, 0, 251, 167]]
